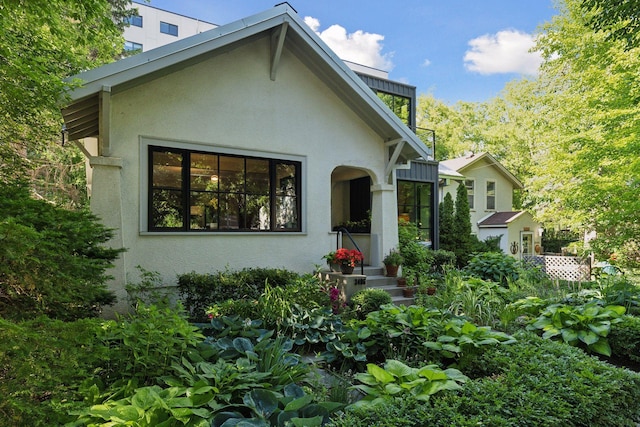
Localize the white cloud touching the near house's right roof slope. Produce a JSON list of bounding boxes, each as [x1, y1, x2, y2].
[[304, 16, 393, 71]]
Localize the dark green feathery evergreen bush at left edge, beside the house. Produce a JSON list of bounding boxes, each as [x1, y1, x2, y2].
[[0, 185, 121, 319]]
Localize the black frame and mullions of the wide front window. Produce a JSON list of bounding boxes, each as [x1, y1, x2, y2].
[[147, 144, 302, 233]]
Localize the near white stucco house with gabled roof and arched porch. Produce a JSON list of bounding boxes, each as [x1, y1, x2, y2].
[[63, 3, 432, 310]]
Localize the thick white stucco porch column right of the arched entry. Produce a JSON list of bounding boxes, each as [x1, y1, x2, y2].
[[370, 184, 398, 265]]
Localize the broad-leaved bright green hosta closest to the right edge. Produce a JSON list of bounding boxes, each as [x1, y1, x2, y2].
[[527, 301, 625, 356]]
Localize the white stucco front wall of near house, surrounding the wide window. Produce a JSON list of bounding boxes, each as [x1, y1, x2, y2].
[[92, 38, 397, 309]]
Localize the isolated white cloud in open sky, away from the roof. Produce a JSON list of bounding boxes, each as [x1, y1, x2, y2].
[[464, 30, 542, 75]]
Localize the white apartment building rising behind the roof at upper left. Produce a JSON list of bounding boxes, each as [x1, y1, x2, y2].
[[124, 2, 218, 52]]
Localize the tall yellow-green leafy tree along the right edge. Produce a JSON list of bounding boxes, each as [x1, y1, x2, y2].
[[534, 0, 640, 260]]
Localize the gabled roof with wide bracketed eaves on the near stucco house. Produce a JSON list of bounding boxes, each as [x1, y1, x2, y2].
[[62, 3, 432, 163]]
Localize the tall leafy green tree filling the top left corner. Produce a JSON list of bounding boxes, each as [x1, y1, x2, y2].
[[0, 0, 129, 197]]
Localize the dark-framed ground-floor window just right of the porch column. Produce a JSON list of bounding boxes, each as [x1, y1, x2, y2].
[[398, 180, 434, 242]]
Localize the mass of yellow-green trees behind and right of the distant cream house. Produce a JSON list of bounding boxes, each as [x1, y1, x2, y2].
[[419, 0, 640, 261]]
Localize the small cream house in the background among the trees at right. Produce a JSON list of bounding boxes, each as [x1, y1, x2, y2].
[[439, 153, 542, 259]]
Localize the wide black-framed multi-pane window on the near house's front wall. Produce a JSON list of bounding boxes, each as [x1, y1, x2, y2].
[[148, 146, 301, 232]]
